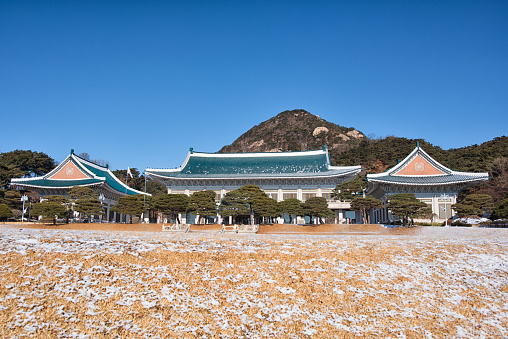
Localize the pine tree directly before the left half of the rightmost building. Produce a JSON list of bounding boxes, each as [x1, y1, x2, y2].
[[387, 193, 432, 226]]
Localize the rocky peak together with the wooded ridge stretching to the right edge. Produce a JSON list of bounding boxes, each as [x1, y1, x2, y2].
[[219, 109, 508, 173]]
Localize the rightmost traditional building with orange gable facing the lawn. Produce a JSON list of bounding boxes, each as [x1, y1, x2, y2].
[[367, 144, 489, 223]]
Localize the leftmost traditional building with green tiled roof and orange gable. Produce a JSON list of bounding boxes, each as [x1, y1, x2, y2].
[[11, 150, 145, 222]]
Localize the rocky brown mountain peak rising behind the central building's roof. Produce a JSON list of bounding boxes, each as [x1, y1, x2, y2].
[[219, 109, 366, 154]]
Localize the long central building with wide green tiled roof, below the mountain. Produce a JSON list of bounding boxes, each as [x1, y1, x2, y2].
[[146, 146, 361, 223]]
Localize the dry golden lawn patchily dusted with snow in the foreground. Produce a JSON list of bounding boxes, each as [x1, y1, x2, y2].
[[0, 228, 508, 338]]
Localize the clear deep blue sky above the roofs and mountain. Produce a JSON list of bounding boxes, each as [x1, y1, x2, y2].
[[0, 0, 508, 169]]
